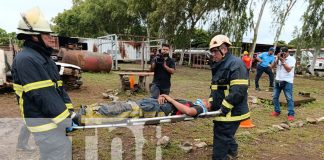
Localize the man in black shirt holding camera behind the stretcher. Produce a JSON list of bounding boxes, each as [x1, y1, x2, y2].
[[151, 44, 175, 99]]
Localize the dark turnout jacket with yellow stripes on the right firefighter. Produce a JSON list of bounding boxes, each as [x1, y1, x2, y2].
[[209, 53, 250, 122]]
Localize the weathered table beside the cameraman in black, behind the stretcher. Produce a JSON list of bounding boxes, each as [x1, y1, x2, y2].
[[114, 72, 154, 92]]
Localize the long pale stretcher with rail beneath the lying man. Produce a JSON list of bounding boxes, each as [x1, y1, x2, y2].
[[73, 111, 222, 129]]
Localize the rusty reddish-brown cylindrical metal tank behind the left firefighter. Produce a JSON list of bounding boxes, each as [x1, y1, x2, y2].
[[58, 49, 112, 73]]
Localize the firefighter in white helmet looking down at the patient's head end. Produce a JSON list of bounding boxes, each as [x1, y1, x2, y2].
[[209, 35, 250, 160]]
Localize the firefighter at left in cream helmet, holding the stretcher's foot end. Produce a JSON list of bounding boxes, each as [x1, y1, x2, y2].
[[12, 7, 75, 159]]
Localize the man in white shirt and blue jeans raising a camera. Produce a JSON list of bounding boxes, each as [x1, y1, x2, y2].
[[271, 47, 296, 121]]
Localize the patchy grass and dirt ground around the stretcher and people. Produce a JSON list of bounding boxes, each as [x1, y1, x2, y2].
[[0, 65, 324, 160]]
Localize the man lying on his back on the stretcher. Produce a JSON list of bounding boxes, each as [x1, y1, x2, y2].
[[79, 94, 210, 125]]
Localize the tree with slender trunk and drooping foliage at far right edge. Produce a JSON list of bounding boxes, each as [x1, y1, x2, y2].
[[301, 0, 324, 74]]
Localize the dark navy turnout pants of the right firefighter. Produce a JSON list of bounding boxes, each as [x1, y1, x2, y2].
[[213, 121, 240, 160]]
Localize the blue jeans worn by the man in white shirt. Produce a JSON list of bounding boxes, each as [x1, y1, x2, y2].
[[273, 81, 295, 116]]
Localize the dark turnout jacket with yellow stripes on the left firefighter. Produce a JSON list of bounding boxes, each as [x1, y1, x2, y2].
[[11, 41, 73, 132]]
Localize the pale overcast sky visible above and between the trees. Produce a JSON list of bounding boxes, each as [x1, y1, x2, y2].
[[0, 0, 306, 44]]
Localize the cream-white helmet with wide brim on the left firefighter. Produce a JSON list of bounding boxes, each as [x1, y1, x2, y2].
[[17, 7, 52, 39]]
